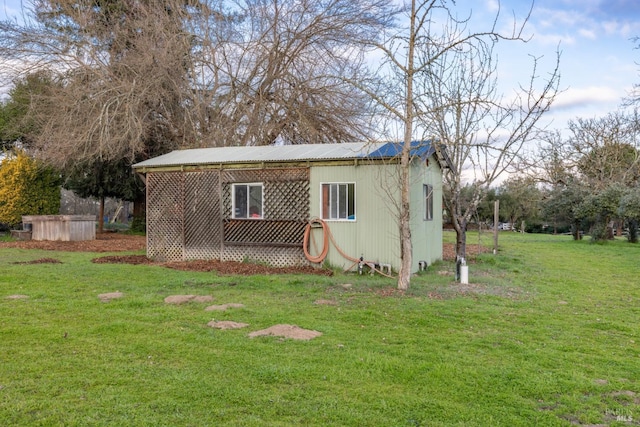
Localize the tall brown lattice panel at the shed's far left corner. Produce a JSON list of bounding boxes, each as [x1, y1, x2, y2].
[[147, 172, 184, 261]]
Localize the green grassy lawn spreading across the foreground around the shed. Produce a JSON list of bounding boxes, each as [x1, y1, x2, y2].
[[0, 233, 640, 426]]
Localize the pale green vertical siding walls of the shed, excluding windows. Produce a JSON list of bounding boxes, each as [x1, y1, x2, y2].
[[310, 159, 442, 271]]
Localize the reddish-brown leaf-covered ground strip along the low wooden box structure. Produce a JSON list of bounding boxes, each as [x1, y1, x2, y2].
[[0, 233, 147, 252]]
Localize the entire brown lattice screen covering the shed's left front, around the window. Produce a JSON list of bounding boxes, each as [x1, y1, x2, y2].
[[147, 168, 310, 266]]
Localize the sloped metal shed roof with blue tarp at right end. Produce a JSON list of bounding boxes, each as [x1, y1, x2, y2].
[[133, 141, 434, 169]]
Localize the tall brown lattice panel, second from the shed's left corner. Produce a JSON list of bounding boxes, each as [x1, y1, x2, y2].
[[184, 170, 222, 260]]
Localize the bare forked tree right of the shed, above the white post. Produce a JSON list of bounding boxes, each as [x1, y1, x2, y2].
[[418, 3, 559, 260]]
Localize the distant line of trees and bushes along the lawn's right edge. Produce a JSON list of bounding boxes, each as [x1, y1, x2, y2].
[[458, 111, 640, 243]]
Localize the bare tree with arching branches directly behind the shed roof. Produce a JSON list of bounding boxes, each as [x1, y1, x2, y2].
[[191, 0, 388, 145]]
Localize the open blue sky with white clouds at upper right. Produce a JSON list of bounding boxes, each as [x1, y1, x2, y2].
[[0, 0, 640, 134]]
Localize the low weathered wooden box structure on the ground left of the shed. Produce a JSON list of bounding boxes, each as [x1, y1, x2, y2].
[[22, 215, 96, 242]]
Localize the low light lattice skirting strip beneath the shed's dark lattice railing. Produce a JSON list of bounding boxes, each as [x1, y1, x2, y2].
[[222, 246, 310, 267]]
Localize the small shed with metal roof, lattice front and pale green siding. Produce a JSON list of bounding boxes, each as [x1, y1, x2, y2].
[[133, 141, 442, 271]]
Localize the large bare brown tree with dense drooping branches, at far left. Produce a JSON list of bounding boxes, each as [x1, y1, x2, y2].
[[0, 0, 194, 167]]
